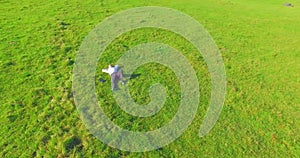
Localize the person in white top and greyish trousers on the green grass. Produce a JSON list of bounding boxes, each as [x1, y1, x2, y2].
[[102, 65, 125, 90]]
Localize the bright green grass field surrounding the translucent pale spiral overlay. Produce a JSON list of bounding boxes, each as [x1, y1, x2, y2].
[[0, 0, 300, 157]]
